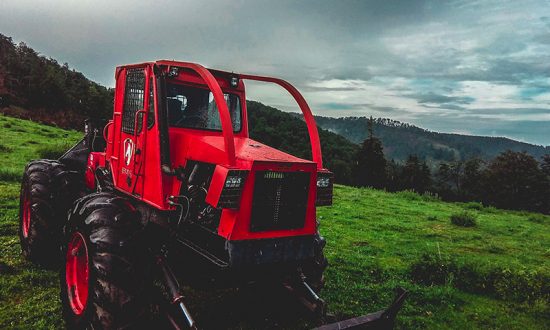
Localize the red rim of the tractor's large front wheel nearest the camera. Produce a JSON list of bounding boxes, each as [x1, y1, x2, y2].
[[65, 232, 88, 315]]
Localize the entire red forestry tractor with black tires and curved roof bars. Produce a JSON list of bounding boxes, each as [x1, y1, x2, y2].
[[20, 61, 405, 329]]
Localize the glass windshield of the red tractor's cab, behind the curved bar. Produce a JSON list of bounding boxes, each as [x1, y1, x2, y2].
[[166, 83, 241, 132]]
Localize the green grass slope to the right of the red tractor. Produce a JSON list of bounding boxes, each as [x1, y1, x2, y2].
[[318, 186, 550, 329]]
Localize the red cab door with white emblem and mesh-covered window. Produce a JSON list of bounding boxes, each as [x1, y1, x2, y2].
[[117, 66, 151, 196]]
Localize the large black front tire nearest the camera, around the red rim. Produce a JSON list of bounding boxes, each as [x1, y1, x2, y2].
[[60, 192, 151, 329]]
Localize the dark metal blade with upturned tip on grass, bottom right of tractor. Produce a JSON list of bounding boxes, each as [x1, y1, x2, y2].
[[314, 288, 408, 330]]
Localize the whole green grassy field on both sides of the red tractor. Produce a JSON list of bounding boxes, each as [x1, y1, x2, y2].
[[0, 116, 550, 329]]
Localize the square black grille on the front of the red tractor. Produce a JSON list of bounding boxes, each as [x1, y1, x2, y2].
[[250, 171, 310, 232]]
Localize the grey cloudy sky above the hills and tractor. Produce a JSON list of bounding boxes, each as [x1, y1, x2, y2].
[[0, 0, 550, 145]]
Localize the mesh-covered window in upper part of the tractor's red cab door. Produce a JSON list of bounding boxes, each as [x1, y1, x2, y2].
[[122, 69, 145, 134]]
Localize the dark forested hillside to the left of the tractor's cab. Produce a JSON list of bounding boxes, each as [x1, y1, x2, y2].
[[0, 34, 114, 128]]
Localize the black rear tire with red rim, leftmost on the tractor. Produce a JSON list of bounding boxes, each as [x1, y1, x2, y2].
[[19, 159, 84, 266]]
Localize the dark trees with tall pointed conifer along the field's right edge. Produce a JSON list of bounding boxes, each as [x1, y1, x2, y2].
[[353, 118, 550, 213]]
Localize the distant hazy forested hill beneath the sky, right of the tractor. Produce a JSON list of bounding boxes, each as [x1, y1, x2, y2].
[[316, 116, 550, 164]]
